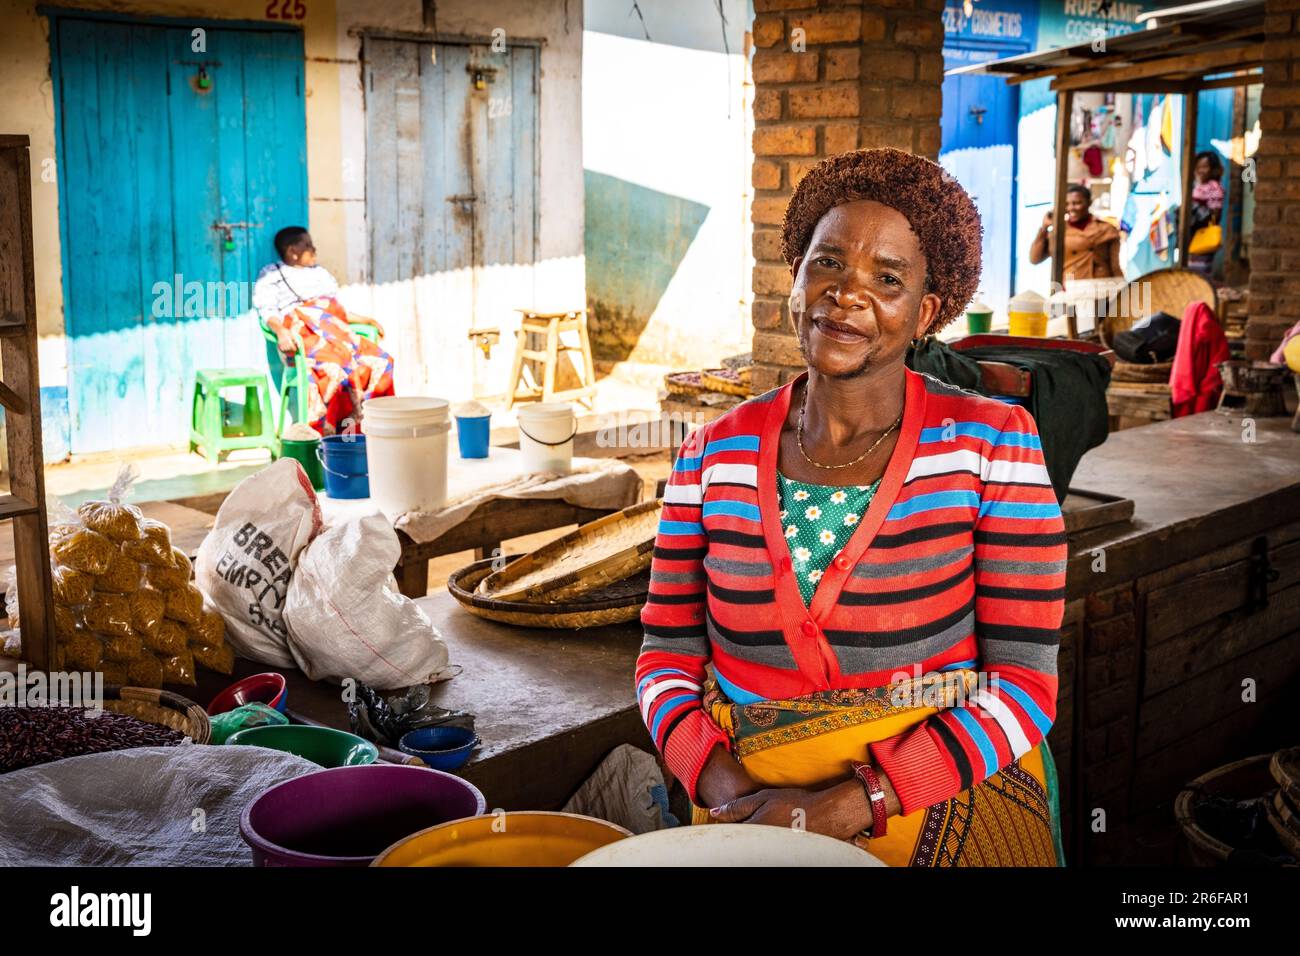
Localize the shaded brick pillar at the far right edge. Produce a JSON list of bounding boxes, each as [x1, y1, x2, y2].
[[1245, 0, 1300, 359]]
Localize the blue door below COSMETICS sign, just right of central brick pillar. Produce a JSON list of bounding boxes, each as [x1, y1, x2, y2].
[[939, 53, 1018, 311]]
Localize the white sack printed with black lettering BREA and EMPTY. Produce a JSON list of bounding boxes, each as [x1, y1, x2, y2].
[[194, 458, 321, 667]]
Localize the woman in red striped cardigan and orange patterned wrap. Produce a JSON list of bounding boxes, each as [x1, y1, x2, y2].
[[636, 150, 1066, 866]]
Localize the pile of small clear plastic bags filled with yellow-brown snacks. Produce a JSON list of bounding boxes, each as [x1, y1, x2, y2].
[[49, 466, 234, 687]]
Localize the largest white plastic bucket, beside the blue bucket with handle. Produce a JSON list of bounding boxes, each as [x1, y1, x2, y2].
[[361, 395, 451, 518]]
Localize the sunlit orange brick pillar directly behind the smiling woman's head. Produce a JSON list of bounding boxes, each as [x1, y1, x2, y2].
[[753, 0, 946, 392]]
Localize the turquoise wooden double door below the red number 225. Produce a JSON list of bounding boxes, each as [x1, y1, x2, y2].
[[53, 16, 307, 454]]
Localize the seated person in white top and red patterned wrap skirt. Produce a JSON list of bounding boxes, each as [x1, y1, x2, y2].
[[252, 226, 393, 434]]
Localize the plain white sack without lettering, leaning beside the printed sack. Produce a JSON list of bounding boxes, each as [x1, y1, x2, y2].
[[285, 514, 451, 691]]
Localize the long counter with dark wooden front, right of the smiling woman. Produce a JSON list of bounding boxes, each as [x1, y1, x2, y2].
[[1048, 412, 1300, 864]]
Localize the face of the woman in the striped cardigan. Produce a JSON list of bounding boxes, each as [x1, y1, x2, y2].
[[790, 199, 940, 378]]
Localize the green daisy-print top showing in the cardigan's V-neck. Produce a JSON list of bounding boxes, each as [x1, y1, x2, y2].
[[776, 472, 880, 605]]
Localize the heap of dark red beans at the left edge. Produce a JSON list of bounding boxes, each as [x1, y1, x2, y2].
[[0, 708, 185, 774]]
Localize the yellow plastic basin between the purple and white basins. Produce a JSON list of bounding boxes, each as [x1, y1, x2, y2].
[[372, 810, 632, 866]]
